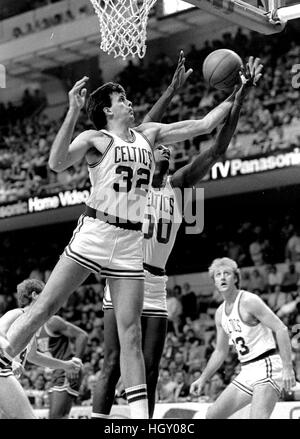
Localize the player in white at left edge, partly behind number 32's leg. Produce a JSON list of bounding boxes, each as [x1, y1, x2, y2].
[[0, 279, 82, 419]]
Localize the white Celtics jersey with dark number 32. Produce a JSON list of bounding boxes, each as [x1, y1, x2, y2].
[[87, 129, 154, 223]]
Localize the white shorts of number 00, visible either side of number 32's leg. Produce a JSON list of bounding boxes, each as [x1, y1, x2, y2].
[[103, 270, 168, 318]]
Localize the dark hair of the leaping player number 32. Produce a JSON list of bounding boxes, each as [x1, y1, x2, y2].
[[86, 82, 125, 130]]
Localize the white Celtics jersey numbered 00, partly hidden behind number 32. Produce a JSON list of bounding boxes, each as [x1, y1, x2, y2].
[[143, 177, 182, 269]]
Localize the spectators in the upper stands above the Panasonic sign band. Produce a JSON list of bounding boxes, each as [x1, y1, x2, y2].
[[0, 27, 300, 204]]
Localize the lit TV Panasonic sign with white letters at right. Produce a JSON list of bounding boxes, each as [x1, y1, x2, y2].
[[210, 148, 300, 180]]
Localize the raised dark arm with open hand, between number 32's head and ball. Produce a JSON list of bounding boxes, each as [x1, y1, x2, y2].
[[143, 50, 193, 123]]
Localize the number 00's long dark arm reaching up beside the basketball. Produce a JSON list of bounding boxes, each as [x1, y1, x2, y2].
[[172, 57, 262, 187]]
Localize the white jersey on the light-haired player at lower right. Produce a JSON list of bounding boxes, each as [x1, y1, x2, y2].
[[222, 290, 276, 363]]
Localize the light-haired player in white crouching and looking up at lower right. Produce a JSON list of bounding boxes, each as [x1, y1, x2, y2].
[[190, 258, 296, 419]]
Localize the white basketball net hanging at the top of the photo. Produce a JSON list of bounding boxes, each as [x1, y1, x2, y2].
[[90, 0, 156, 59]]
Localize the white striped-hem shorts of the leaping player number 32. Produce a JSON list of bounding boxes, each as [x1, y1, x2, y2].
[[64, 215, 145, 279]]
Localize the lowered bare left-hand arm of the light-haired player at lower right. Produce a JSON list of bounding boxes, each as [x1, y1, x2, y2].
[[190, 305, 229, 395]]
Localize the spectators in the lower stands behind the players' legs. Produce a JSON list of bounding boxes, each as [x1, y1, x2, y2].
[[1, 260, 300, 408]]
